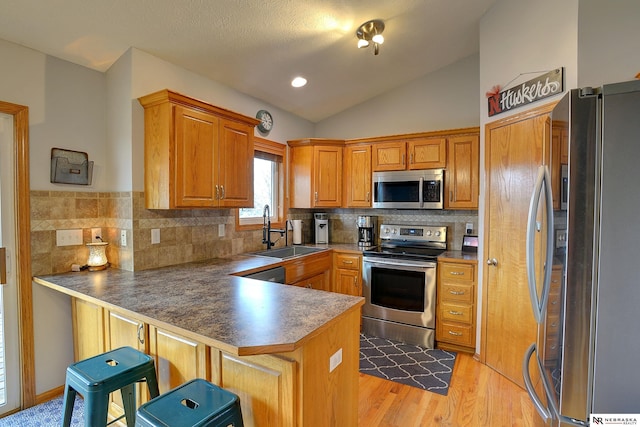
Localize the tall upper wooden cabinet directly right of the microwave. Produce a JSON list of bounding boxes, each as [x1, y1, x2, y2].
[[444, 134, 480, 209]]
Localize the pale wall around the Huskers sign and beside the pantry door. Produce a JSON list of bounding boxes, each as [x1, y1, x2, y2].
[[476, 0, 578, 354]]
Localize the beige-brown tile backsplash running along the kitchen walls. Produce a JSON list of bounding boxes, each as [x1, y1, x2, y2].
[[31, 191, 478, 275]]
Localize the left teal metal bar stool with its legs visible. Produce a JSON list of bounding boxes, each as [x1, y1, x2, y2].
[[62, 347, 160, 427]]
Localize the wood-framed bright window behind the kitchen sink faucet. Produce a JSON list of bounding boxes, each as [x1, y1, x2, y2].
[[236, 138, 286, 229]]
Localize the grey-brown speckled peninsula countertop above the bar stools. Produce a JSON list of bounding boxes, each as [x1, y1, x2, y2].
[[34, 255, 364, 356]]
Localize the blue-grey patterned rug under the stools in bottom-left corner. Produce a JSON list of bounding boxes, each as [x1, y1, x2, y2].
[[0, 396, 84, 427]]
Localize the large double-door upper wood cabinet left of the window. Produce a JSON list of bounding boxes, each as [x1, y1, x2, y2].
[[139, 90, 258, 209]]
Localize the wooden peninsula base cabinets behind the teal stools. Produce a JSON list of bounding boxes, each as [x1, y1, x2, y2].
[[72, 298, 360, 427]]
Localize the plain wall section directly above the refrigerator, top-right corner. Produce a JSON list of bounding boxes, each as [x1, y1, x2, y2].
[[578, 0, 640, 87]]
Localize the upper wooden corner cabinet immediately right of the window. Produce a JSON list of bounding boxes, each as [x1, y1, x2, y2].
[[289, 139, 344, 208]]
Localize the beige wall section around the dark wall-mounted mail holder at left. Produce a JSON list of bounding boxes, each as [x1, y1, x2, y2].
[[0, 40, 109, 191]]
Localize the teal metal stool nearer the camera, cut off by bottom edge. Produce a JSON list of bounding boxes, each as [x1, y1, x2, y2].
[[136, 379, 244, 427]]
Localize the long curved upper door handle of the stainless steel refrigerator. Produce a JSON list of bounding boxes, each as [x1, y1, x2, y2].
[[526, 165, 554, 324]]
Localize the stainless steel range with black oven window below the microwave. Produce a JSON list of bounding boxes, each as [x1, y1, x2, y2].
[[362, 224, 447, 348]]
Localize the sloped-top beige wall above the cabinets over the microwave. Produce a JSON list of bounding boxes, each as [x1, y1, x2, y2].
[[315, 51, 480, 139]]
